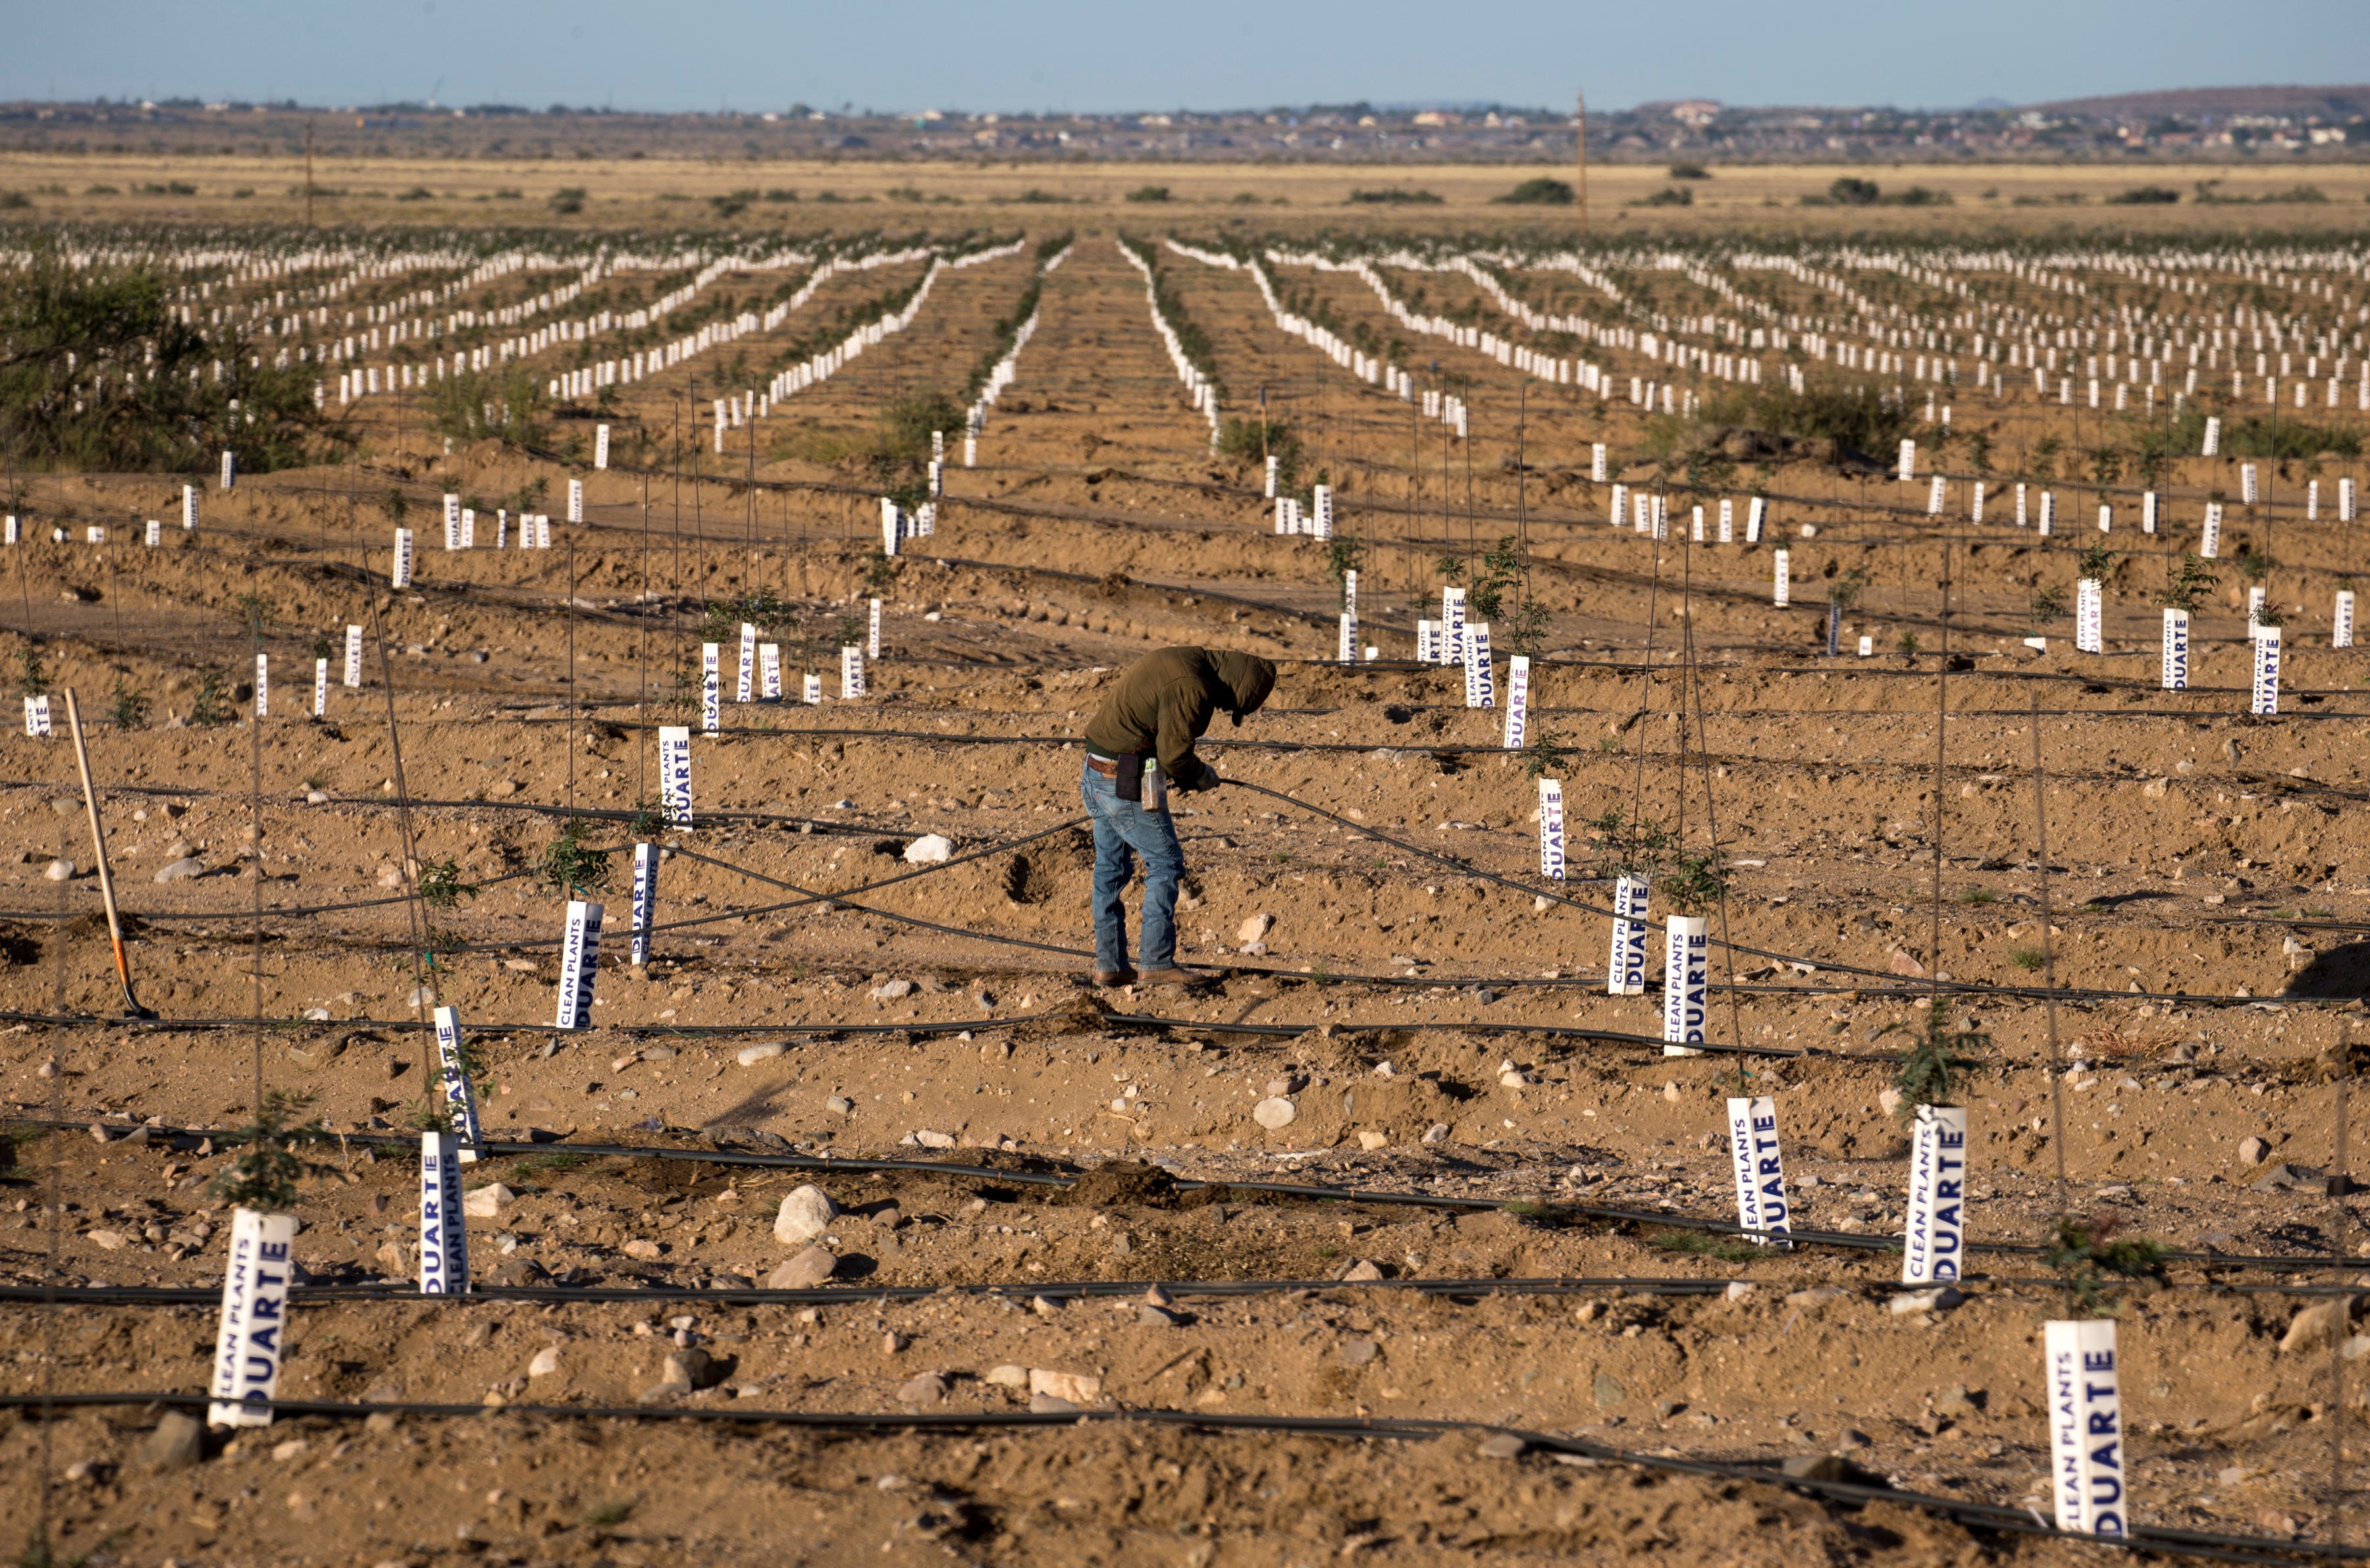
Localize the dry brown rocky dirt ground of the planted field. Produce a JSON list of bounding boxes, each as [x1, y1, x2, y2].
[[0, 215, 2370, 1568]]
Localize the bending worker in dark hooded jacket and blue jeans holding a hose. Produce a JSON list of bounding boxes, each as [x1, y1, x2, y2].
[[1078, 649, 1275, 985]]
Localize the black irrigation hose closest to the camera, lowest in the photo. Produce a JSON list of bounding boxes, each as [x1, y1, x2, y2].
[[0, 1390, 2370, 1563]]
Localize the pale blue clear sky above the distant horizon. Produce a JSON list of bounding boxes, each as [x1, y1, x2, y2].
[[0, 0, 2370, 111]]
